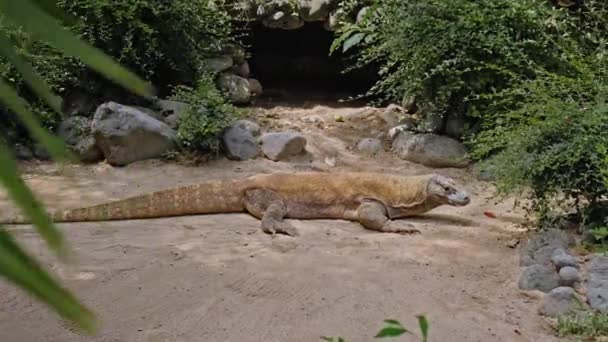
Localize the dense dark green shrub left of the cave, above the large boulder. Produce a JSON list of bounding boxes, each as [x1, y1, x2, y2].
[[59, 0, 238, 89]]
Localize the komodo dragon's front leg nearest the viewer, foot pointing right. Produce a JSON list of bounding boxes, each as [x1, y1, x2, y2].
[[357, 201, 420, 234]]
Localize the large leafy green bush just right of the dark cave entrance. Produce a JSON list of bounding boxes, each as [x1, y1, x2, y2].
[[330, 0, 569, 123]]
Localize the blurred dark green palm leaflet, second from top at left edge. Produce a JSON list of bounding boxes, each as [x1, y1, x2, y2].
[[0, 34, 61, 113]]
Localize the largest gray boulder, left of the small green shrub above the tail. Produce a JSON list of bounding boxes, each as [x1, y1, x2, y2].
[[91, 102, 176, 166]]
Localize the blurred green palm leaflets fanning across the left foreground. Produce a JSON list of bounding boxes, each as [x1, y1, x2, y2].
[[0, 0, 153, 333]]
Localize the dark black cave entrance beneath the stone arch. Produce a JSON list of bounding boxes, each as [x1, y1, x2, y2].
[[249, 22, 375, 102]]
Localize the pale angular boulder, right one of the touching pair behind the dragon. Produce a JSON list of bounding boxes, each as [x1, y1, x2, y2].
[[260, 132, 306, 161]]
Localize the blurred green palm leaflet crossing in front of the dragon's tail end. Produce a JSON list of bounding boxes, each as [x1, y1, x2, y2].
[[0, 143, 67, 257]]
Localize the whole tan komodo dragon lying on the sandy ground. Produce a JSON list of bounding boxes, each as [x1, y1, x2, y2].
[[2, 172, 470, 236]]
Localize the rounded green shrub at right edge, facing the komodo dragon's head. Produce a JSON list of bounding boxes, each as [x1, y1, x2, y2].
[[471, 71, 608, 225]]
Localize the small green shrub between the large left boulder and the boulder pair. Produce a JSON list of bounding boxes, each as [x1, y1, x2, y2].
[[172, 76, 239, 153]]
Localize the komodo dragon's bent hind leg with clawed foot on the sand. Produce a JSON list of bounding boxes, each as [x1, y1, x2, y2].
[[245, 189, 298, 236]]
